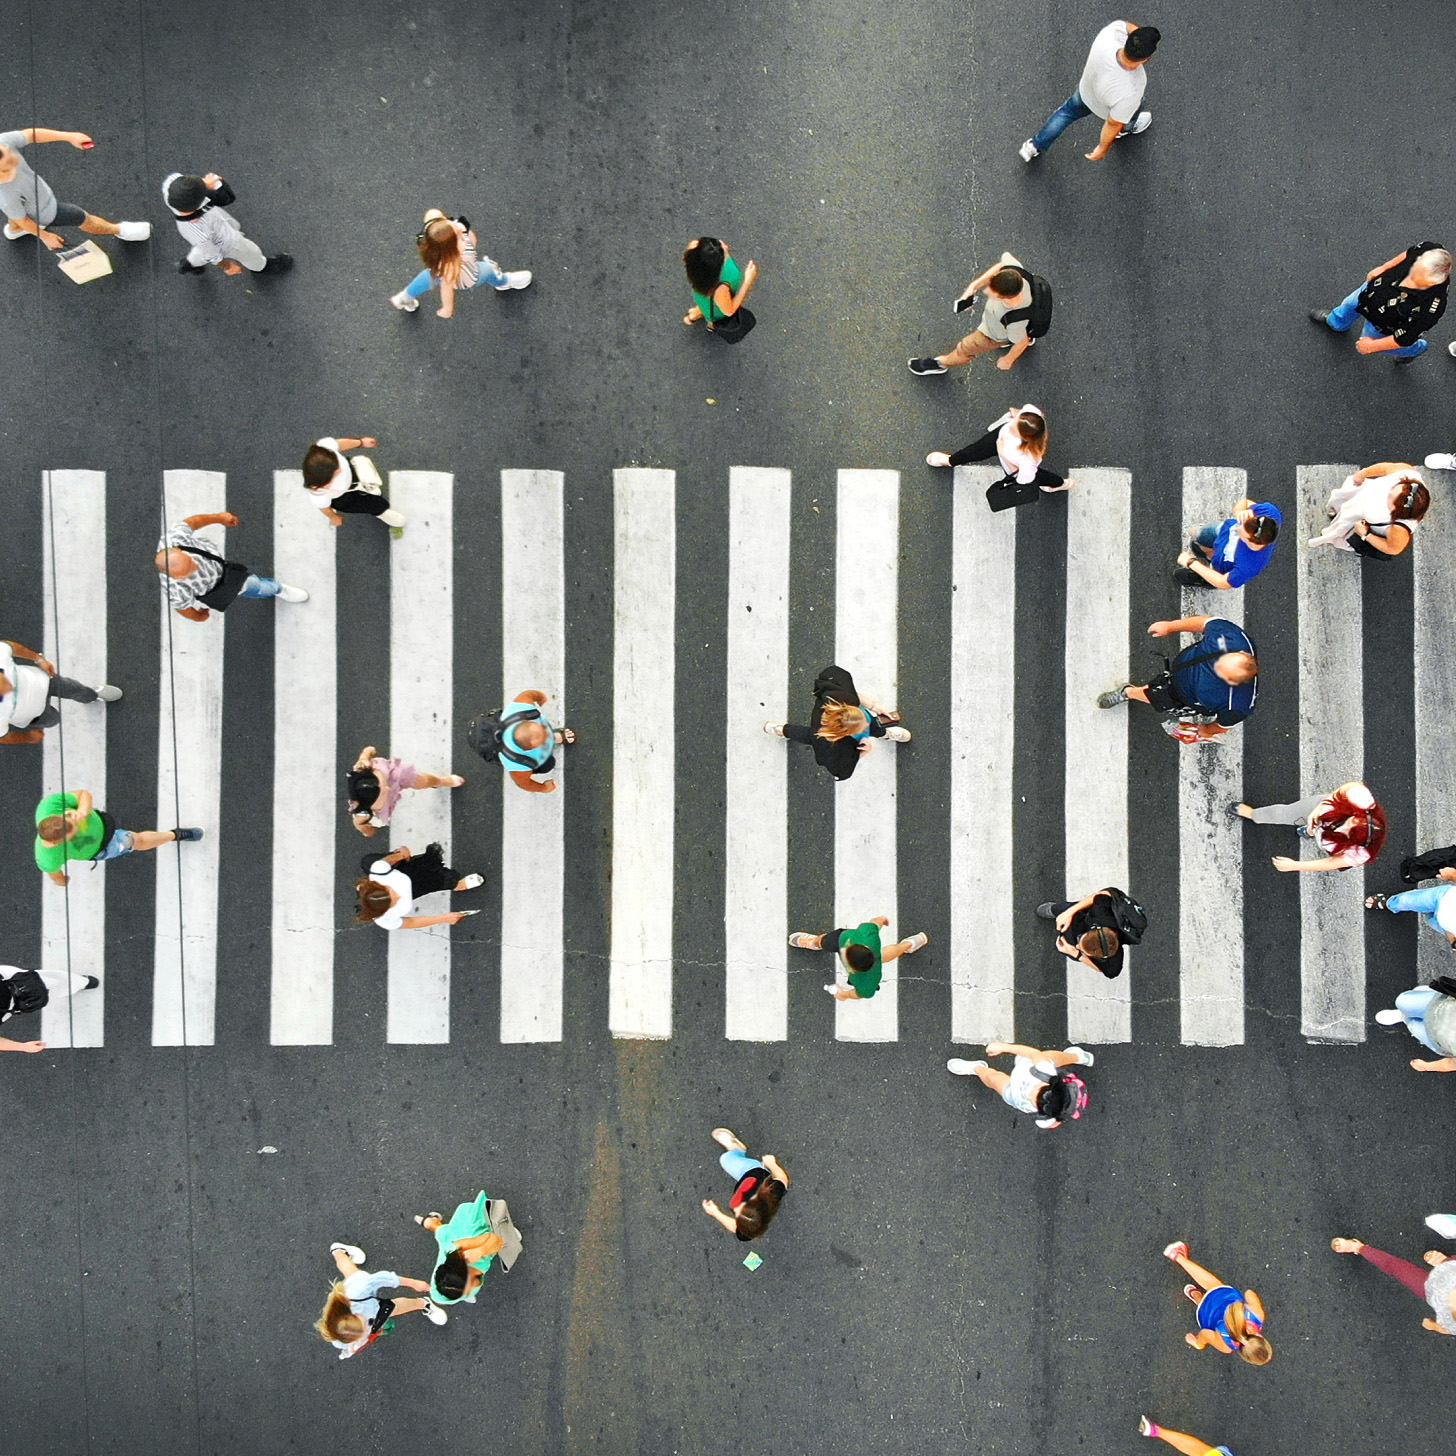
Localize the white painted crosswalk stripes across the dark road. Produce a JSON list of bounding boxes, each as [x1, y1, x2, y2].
[[25, 464, 1456, 1047]]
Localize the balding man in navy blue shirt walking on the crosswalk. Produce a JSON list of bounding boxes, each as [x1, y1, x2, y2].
[[1096, 617, 1259, 743]]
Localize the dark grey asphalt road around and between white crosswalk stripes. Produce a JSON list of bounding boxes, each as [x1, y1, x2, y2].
[[0, 0, 1456, 1456]]
